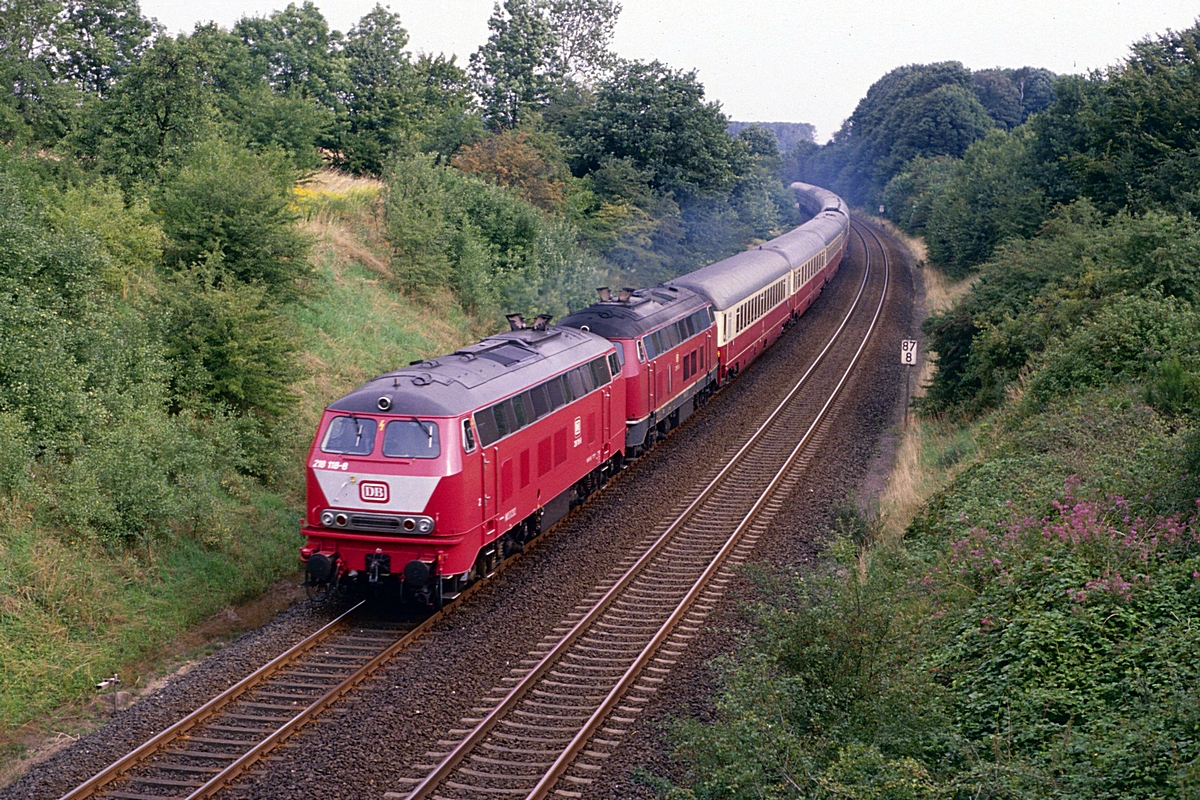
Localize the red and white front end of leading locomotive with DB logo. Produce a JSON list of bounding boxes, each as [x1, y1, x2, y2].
[[300, 374, 479, 599]]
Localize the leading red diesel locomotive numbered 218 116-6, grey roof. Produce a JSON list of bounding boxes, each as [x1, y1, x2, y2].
[[300, 318, 625, 603]]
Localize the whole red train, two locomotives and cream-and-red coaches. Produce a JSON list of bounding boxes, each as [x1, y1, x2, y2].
[[300, 182, 850, 608]]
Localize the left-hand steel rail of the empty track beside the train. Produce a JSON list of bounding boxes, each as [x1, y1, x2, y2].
[[407, 217, 882, 800]]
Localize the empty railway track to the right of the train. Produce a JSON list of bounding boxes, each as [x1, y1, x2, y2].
[[385, 219, 889, 800]]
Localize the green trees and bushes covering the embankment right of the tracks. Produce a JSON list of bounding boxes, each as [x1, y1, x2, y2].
[[664, 20, 1200, 800]]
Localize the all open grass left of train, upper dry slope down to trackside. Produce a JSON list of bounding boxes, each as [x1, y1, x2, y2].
[[0, 165, 482, 783]]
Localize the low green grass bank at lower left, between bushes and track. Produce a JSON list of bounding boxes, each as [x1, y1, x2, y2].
[[0, 489, 299, 752]]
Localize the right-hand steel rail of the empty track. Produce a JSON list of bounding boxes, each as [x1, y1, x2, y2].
[[526, 215, 890, 800]]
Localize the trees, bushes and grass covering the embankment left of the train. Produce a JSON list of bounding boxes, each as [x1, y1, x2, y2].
[[0, 0, 816, 767]]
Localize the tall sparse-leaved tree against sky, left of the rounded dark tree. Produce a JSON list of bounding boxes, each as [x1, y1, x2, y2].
[[470, 0, 559, 130]]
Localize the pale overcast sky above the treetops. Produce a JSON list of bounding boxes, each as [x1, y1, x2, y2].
[[142, 0, 1200, 142]]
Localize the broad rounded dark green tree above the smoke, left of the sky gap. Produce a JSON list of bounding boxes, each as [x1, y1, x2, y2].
[[575, 61, 739, 197]]
